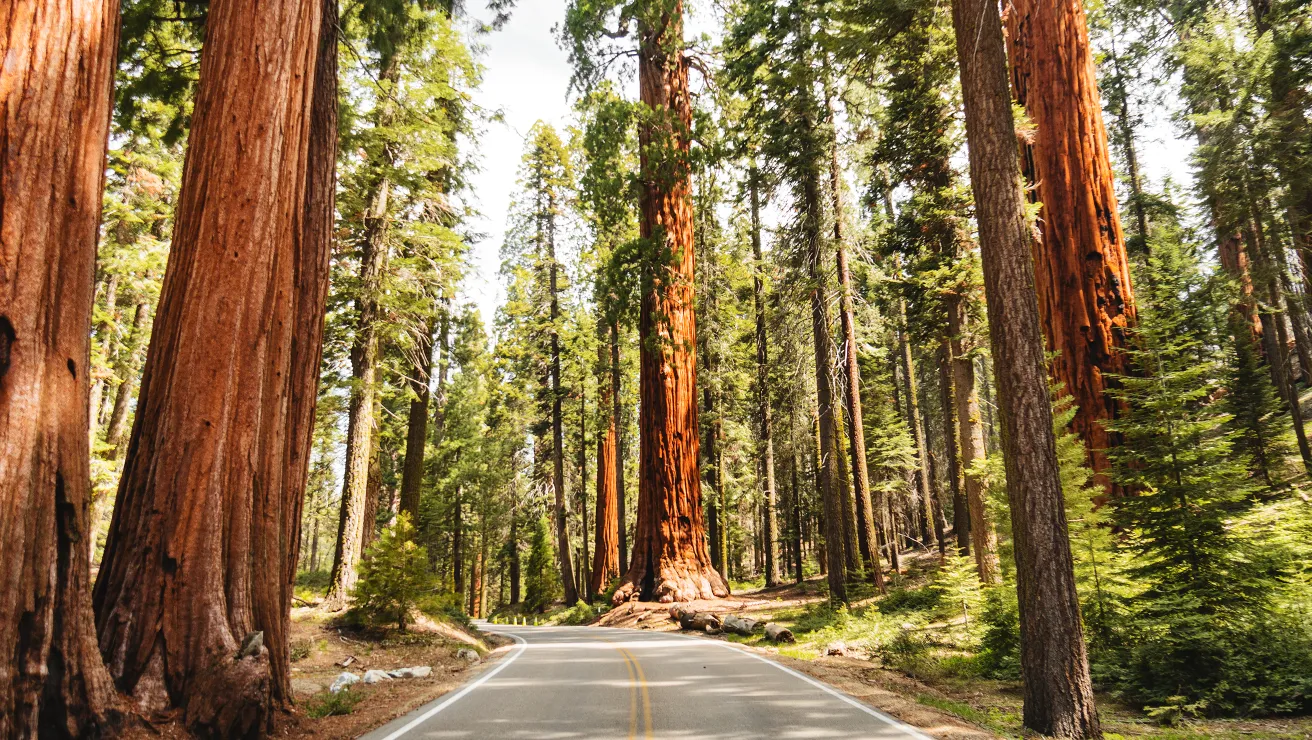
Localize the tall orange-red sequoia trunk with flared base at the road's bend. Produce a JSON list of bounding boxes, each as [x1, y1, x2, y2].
[[614, 0, 729, 604]]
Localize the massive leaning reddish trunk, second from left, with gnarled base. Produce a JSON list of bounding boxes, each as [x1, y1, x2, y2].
[[94, 0, 330, 737]]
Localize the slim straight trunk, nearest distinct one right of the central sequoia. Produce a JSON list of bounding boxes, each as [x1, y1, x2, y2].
[[748, 165, 779, 588]]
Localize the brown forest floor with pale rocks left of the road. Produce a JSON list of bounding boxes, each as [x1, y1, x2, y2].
[[274, 607, 512, 740]]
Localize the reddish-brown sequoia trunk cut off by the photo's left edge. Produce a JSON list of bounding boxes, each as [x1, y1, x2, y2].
[[0, 0, 119, 739]]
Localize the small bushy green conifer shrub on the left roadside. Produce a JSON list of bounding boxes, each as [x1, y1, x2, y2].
[[352, 513, 432, 631]]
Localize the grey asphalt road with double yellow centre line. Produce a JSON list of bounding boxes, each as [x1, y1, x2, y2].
[[365, 626, 929, 740]]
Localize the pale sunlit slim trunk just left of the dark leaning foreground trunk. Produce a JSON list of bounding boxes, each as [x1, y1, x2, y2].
[[947, 295, 1002, 585]]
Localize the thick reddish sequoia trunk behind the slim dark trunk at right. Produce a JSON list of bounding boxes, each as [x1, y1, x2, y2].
[[1006, 0, 1135, 495]]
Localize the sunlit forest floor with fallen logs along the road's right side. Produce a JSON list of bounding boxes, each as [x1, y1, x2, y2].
[[582, 552, 1312, 740]]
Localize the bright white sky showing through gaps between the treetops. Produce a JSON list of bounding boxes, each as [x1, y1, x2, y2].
[[463, 0, 1193, 328]]
